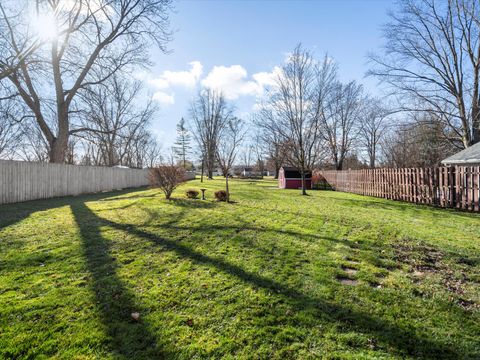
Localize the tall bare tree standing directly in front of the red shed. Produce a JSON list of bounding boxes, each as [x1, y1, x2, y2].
[[268, 45, 335, 195]]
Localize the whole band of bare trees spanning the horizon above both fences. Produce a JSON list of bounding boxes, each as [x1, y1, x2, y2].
[[0, 0, 480, 190]]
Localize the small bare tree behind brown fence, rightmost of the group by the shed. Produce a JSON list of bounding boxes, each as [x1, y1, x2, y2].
[[358, 98, 391, 169]]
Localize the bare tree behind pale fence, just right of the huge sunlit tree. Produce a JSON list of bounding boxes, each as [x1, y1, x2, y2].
[[81, 74, 157, 167]]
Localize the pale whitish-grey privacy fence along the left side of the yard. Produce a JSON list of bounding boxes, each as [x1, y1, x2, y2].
[[0, 160, 148, 204]]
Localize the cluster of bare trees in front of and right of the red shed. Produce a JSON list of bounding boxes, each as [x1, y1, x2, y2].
[[254, 45, 391, 193]]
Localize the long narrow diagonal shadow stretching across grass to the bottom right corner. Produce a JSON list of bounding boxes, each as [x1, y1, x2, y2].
[[85, 212, 468, 359]]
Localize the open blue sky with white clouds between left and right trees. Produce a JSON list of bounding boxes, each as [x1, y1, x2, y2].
[[143, 0, 394, 150]]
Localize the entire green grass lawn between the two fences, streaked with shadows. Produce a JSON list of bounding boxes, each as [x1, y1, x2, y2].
[[0, 179, 480, 359]]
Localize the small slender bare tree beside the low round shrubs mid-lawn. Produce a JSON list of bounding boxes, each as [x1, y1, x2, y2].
[[217, 117, 246, 202]]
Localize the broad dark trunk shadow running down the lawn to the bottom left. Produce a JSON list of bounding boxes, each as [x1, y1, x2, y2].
[[70, 200, 166, 359]]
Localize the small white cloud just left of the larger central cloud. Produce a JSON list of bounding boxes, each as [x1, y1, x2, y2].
[[148, 61, 203, 90]]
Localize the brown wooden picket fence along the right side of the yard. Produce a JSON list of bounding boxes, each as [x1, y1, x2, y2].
[[320, 166, 480, 211]]
